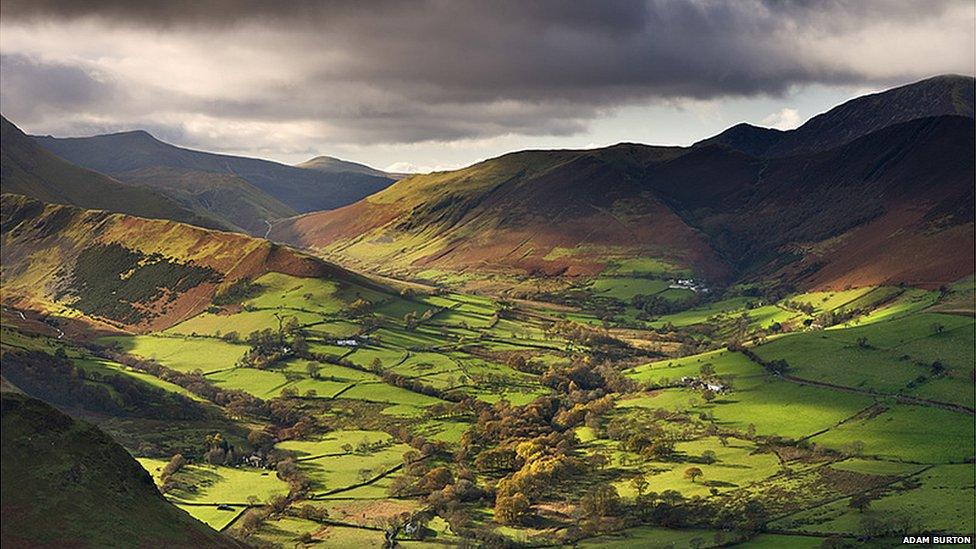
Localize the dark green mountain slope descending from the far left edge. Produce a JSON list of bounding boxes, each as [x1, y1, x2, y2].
[[0, 117, 215, 227]]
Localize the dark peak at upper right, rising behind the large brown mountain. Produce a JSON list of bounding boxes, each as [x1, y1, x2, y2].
[[696, 75, 974, 157]]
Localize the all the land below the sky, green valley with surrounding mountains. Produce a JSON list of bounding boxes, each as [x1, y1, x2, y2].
[[0, 77, 976, 548]]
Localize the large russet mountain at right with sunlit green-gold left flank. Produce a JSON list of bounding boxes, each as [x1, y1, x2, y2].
[[271, 112, 976, 287]]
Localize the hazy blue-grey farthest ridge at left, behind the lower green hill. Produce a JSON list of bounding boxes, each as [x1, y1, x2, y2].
[[35, 131, 393, 218]]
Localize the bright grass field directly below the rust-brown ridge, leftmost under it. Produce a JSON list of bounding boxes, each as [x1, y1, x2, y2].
[[99, 335, 247, 374]]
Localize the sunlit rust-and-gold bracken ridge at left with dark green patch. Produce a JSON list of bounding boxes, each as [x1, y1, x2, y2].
[[0, 194, 388, 332]]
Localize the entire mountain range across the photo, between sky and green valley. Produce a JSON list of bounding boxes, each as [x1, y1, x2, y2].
[[2, 76, 974, 287]]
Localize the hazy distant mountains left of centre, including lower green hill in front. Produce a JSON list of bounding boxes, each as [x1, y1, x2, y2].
[[19, 127, 399, 234]]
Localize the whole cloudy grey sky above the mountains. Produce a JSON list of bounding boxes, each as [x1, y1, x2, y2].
[[0, 0, 976, 171]]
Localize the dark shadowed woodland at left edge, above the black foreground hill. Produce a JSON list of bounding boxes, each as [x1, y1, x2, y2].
[[3, 347, 210, 420]]
